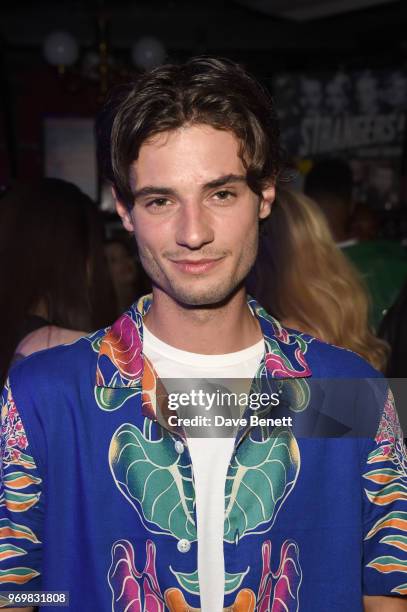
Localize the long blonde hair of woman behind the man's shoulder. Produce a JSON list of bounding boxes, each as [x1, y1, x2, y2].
[[248, 189, 388, 370]]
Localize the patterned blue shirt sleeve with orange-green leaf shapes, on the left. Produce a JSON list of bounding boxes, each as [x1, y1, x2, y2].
[[0, 381, 43, 607]]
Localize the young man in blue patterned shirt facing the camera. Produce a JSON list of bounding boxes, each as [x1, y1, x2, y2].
[[0, 58, 407, 612]]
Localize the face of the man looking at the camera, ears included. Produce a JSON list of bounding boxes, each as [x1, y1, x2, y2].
[[117, 124, 275, 306]]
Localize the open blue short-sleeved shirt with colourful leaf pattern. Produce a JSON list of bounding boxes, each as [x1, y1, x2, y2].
[[0, 296, 407, 612]]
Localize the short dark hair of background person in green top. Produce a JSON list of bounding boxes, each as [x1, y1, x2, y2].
[[304, 158, 353, 203]]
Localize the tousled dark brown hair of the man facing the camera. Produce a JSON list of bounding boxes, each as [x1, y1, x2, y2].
[[96, 57, 283, 208]]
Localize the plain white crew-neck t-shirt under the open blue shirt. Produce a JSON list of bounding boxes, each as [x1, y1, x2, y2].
[[143, 326, 264, 612]]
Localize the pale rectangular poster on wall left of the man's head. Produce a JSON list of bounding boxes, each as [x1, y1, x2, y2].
[[43, 116, 98, 200]]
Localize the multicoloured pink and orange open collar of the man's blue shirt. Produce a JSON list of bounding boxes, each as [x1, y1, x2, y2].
[[96, 295, 312, 394]]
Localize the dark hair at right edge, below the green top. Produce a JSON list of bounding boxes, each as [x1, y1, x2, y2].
[[379, 282, 407, 378]]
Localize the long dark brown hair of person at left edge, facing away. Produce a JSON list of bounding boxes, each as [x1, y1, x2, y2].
[[0, 179, 115, 380]]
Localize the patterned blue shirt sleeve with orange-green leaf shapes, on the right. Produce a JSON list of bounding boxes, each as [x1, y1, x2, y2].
[[362, 391, 407, 596]]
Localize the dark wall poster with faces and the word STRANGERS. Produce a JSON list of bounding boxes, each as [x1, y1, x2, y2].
[[273, 70, 407, 210]]
